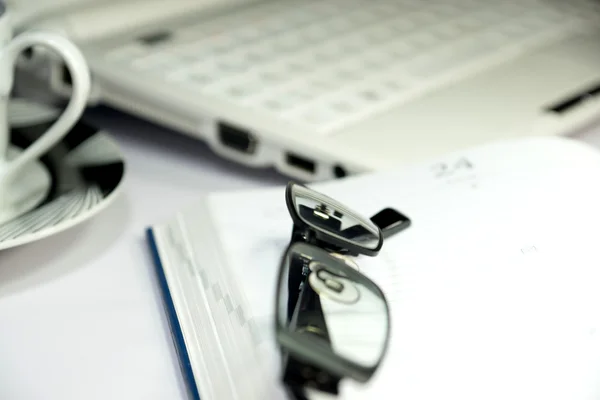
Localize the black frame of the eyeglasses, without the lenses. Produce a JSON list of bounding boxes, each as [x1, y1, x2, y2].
[[275, 182, 411, 400]]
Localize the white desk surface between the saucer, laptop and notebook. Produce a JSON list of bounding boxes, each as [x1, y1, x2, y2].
[[0, 107, 600, 400]]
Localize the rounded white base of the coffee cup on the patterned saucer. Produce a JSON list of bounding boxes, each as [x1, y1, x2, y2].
[[0, 145, 52, 226]]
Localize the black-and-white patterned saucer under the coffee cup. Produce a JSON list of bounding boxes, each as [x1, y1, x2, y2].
[[0, 99, 125, 250]]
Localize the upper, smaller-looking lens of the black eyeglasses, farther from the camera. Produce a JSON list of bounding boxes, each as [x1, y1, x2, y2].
[[291, 185, 381, 250]]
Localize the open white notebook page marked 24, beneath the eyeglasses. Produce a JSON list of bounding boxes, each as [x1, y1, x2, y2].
[[191, 136, 600, 399]]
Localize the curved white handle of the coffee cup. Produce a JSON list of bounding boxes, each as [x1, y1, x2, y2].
[[0, 32, 91, 177]]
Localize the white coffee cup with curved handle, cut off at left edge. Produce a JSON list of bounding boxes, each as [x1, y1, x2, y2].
[[0, 7, 91, 224]]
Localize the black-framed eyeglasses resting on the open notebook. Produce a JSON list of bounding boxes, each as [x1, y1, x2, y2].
[[276, 182, 411, 399]]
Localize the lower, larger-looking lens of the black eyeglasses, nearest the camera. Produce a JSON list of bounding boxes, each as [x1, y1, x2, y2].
[[278, 243, 389, 376]]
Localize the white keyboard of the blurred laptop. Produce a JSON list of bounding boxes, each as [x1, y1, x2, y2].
[[107, 0, 600, 134]]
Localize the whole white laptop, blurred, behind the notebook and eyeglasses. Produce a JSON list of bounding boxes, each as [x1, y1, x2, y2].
[[9, 0, 600, 181]]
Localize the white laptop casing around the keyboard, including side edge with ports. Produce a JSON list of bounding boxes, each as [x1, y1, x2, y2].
[[9, 0, 600, 180]]
